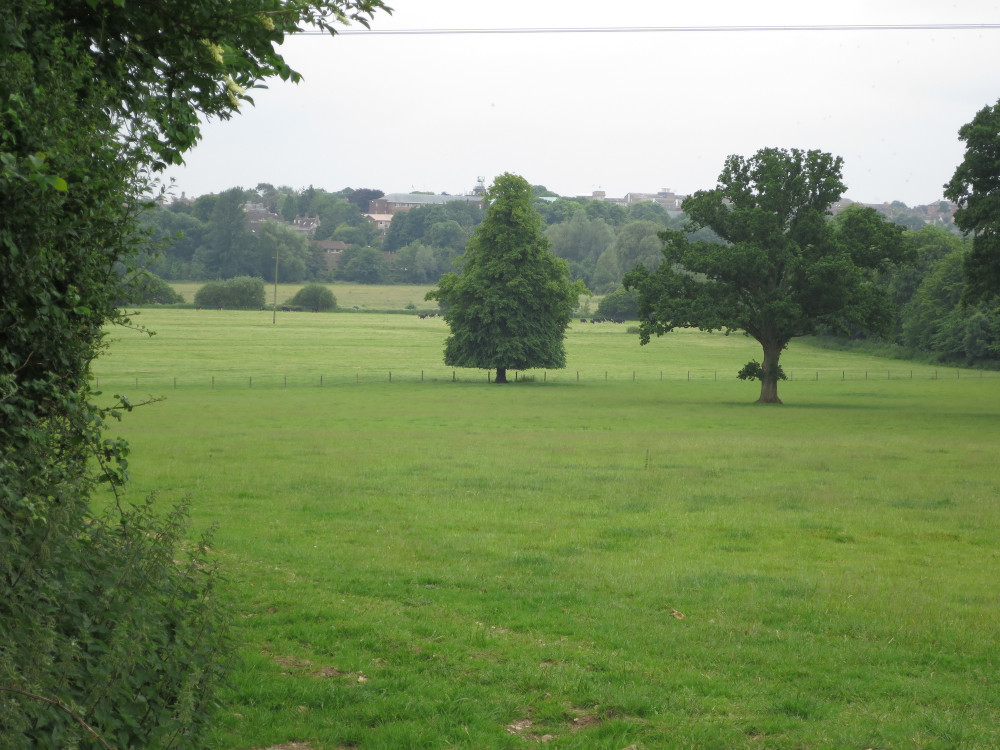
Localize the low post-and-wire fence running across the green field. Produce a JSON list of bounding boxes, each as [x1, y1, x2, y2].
[[94, 367, 1000, 390]]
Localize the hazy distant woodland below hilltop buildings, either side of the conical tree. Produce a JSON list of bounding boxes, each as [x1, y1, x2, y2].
[[143, 183, 712, 293]]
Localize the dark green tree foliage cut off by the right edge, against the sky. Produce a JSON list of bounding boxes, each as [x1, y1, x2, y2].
[[944, 102, 1000, 302]]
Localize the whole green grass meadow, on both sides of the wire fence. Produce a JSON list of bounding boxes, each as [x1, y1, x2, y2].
[[95, 308, 1000, 750]]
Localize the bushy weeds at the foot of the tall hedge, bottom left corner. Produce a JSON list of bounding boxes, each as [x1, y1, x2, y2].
[[0, 497, 231, 750]]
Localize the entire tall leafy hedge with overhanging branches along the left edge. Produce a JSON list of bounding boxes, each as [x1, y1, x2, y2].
[[0, 0, 384, 750]]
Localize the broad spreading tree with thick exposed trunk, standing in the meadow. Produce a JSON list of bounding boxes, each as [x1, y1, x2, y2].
[[625, 148, 906, 403]]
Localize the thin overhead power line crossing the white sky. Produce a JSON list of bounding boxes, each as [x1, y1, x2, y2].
[[301, 23, 1000, 36]]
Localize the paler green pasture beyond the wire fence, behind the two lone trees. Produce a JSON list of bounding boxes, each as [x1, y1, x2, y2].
[[95, 308, 976, 390]]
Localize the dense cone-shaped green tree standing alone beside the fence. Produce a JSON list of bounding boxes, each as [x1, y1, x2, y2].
[[427, 174, 586, 383]]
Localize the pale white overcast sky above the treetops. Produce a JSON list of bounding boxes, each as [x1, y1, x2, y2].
[[160, 0, 1000, 205]]
